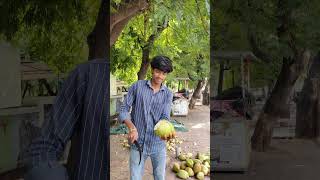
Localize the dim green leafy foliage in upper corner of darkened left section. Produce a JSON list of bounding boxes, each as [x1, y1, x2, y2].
[[0, 0, 100, 72]]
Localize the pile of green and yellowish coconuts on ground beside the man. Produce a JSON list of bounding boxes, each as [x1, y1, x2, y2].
[[172, 153, 210, 179]]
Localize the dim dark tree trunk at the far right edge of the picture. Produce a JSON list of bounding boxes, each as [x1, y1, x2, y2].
[[296, 56, 320, 138]]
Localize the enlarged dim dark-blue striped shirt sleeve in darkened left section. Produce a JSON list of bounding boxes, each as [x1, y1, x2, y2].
[[23, 66, 87, 166]]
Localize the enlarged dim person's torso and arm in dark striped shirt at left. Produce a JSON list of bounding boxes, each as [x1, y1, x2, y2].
[[22, 59, 110, 180]]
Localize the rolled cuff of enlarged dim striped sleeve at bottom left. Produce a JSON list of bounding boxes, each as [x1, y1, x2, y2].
[[24, 162, 68, 180]]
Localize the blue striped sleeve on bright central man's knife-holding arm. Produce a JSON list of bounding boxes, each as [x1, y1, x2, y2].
[[118, 83, 137, 123]]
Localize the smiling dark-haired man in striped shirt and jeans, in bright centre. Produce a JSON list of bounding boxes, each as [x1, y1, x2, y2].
[[119, 56, 174, 180]]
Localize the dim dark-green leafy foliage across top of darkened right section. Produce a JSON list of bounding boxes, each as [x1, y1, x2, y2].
[[212, 0, 320, 90]]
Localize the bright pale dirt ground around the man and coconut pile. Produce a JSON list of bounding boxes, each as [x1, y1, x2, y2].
[[110, 106, 210, 180]]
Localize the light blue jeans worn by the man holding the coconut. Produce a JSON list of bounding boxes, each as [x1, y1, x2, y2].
[[130, 146, 166, 180]]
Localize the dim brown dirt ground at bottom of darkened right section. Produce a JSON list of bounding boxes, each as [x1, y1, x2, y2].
[[213, 139, 320, 180]]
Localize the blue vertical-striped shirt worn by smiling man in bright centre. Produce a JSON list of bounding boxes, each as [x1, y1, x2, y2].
[[119, 80, 173, 154]]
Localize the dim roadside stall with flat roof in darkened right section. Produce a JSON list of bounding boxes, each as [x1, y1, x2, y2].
[[210, 52, 257, 171]]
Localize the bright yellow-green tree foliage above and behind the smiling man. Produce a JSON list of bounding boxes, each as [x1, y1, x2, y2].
[[111, 0, 210, 86]]
